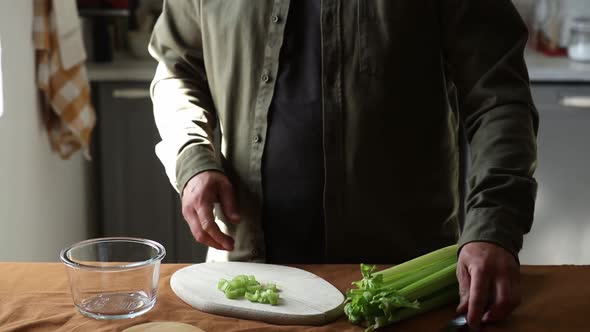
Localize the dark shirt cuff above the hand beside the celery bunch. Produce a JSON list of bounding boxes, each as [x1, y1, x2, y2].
[[458, 208, 524, 262]]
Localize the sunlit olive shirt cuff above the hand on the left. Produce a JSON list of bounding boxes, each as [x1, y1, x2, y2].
[[176, 145, 223, 196]]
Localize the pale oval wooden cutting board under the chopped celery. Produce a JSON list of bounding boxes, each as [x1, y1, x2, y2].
[[170, 262, 344, 325]]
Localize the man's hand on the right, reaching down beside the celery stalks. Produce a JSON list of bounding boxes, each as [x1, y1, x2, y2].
[[457, 242, 520, 330]]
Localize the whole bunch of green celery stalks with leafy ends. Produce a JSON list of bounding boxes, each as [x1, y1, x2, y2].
[[344, 245, 458, 331]]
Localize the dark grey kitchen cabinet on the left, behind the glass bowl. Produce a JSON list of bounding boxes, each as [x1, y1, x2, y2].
[[93, 81, 206, 262]]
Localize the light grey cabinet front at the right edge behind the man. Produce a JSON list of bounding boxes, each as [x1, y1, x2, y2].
[[521, 83, 590, 264]]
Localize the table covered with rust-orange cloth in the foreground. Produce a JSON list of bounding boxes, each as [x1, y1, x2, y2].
[[0, 263, 590, 332]]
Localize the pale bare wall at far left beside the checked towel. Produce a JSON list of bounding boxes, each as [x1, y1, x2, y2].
[[0, 0, 89, 261]]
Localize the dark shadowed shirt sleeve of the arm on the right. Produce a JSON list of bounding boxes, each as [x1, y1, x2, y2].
[[441, 0, 538, 257]]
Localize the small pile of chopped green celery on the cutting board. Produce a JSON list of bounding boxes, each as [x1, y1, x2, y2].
[[217, 275, 279, 305]]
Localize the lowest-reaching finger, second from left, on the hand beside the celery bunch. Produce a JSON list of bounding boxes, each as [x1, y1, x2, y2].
[[467, 268, 490, 331]]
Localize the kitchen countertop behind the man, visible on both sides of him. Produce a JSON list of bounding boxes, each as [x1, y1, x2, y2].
[[87, 49, 590, 82]]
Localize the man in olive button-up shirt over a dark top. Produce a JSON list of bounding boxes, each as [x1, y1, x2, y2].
[[150, 0, 538, 328]]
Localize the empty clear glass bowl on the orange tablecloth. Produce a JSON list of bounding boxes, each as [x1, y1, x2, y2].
[[60, 237, 166, 319]]
